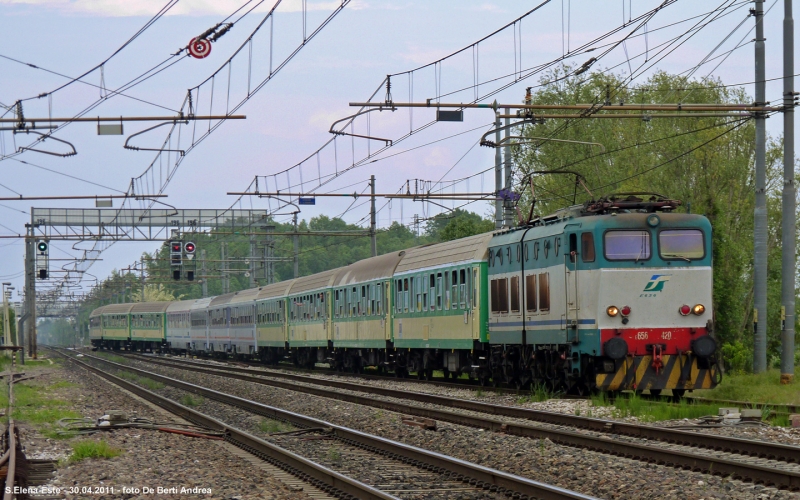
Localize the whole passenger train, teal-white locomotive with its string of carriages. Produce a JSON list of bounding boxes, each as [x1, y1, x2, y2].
[[89, 195, 722, 396]]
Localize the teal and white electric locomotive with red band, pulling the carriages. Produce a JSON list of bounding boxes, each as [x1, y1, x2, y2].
[[481, 196, 721, 395]]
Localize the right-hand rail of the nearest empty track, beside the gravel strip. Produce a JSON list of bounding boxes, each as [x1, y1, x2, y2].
[[65, 354, 594, 500]]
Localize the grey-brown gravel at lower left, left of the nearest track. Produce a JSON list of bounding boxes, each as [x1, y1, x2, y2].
[[20, 363, 309, 500]]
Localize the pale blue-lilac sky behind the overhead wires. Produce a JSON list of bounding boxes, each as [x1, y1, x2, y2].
[[0, 0, 783, 308]]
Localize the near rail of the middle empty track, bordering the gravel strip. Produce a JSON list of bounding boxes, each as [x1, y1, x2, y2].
[[112, 358, 800, 491]]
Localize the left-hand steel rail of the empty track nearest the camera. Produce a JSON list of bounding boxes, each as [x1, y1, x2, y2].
[[47, 349, 398, 500]]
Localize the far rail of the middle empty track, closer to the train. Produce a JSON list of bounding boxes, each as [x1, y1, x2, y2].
[[126, 356, 800, 463]]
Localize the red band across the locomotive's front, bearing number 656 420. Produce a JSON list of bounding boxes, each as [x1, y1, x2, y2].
[[600, 328, 708, 356]]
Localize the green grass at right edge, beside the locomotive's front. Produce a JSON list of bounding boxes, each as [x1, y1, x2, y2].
[[692, 370, 800, 405]]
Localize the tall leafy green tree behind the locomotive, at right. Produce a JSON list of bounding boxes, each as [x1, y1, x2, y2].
[[514, 68, 796, 370]]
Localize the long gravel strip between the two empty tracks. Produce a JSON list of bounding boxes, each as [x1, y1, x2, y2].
[[120, 361, 800, 500]]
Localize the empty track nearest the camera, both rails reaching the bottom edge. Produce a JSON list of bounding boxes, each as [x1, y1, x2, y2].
[[53, 351, 592, 500]]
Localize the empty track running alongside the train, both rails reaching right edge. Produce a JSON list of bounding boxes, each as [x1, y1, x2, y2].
[[112, 355, 800, 490]]
